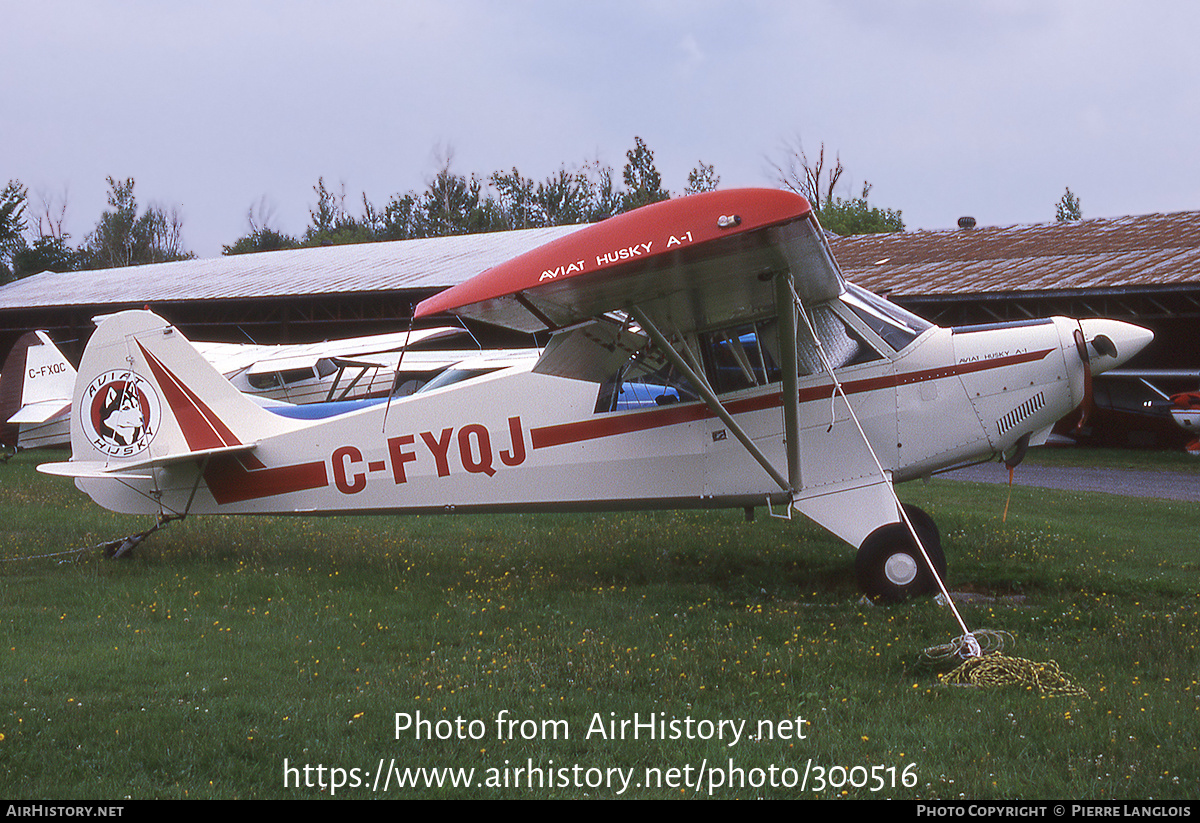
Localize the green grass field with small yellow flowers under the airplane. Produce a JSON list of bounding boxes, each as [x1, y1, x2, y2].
[[0, 455, 1200, 799]]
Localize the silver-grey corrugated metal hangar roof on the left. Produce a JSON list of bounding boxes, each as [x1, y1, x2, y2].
[[0, 226, 583, 310]]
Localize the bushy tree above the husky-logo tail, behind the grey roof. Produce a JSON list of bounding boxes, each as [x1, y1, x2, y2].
[[79, 178, 194, 269]]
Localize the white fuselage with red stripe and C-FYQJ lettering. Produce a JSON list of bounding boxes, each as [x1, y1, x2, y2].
[[77, 286, 1148, 527]]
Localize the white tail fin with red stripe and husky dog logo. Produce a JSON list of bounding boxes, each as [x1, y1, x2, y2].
[[71, 311, 288, 470]]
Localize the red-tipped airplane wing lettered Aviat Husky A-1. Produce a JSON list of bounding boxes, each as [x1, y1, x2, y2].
[[415, 188, 844, 334]]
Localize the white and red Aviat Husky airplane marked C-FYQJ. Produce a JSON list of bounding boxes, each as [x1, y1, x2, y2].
[[40, 190, 1152, 597]]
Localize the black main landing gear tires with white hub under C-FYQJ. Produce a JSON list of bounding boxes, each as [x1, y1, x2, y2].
[[854, 504, 946, 602]]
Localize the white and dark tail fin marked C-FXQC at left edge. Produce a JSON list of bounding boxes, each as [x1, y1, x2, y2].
[[0, 331, 76, 449]]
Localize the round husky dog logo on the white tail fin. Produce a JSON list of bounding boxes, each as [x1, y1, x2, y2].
[[80, 371, 161, 457]]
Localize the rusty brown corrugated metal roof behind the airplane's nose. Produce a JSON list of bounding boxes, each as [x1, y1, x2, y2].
[[832, 211, 1200, 296]]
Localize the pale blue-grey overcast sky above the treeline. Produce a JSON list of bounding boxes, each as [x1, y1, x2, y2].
[[9, 0, 1200, 257]]
